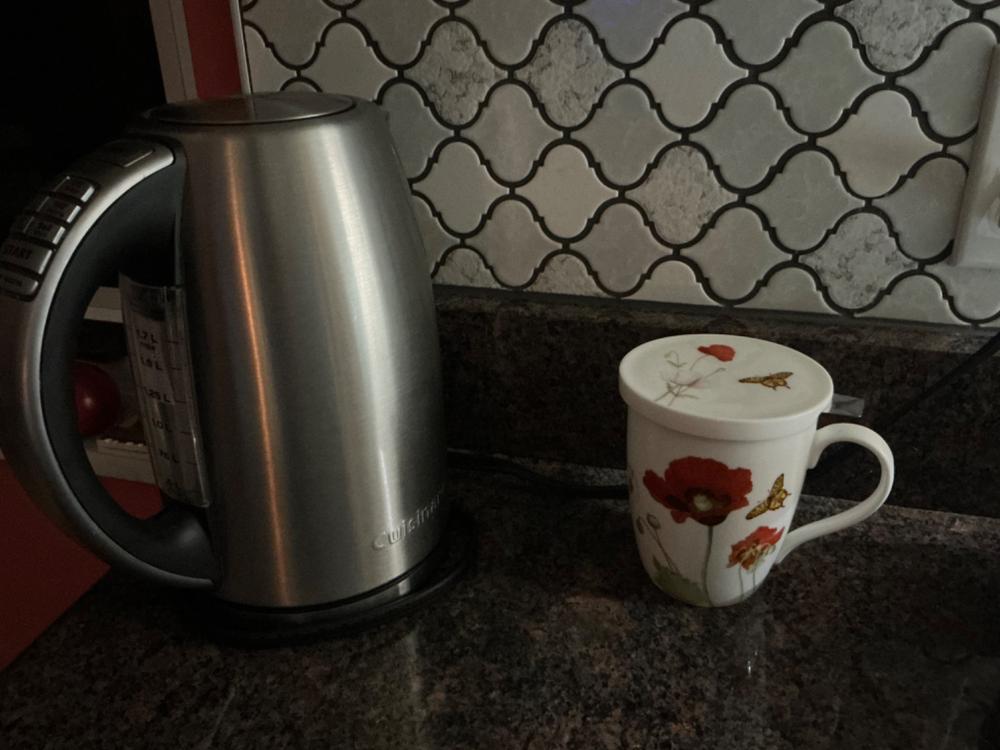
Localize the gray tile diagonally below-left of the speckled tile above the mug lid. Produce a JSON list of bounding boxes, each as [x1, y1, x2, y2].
[[574, 203, 670, 292]]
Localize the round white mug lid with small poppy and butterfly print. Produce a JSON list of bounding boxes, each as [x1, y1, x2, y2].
[[618, 333, 833, 440]]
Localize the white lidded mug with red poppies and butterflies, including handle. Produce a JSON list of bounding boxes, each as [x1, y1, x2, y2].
[[619, 334, 893, 607]]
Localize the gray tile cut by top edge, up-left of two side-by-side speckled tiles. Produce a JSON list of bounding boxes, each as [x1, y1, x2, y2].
[[347, 0, 447, 65]]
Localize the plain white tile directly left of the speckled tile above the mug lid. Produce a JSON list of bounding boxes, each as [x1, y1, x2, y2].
[[517, 144, 615, 238]]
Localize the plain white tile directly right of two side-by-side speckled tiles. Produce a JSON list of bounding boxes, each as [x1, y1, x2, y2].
[[632, 18, 746, 127]]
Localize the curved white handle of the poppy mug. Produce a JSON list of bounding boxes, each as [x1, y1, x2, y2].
[[775, 424, 895, 565]]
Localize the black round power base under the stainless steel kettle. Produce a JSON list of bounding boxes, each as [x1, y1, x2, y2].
[[187, 510, 475, 648]]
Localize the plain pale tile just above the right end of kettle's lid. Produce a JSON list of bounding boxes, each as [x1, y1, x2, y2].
[[307, 23, 395, 99]]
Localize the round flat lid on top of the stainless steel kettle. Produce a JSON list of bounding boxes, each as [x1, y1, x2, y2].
[[145, 91, 354, 125]]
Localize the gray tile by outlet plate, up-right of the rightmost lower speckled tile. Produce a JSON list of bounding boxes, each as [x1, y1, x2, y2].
[[875, 156, 965, 258]]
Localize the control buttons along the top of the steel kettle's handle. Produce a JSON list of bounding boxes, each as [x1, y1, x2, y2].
[[0, 139, 154, 300]]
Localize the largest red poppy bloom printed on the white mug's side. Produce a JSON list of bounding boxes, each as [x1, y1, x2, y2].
[[642, 456, 753, 526]]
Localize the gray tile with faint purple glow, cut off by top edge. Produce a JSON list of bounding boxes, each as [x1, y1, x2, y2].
[[573, 0, 687, 63]]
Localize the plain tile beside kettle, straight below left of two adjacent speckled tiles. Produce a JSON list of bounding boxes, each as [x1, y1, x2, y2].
[[413, 142, 505, 233]]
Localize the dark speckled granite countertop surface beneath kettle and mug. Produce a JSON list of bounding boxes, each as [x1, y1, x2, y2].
[[0, 472, 1000, 750]]
